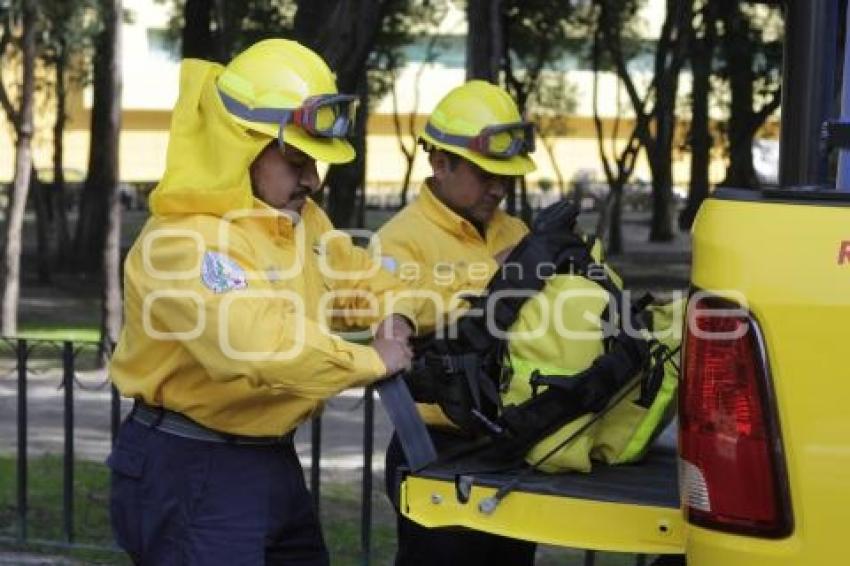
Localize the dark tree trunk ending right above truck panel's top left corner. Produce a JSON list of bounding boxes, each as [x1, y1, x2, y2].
[[679, 2, 717, 232]]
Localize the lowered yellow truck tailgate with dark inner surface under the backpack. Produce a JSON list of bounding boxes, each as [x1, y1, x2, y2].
[[400, 426, 685, 554]]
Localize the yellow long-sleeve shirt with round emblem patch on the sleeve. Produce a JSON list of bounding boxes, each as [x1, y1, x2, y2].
[[111, 203, 424, 435]]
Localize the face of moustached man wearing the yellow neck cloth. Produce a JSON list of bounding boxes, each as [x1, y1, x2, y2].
[[251, 142, 320, 214]]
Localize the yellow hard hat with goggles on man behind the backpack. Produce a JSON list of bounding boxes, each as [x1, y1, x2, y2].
[[419, 81, 536, 175]]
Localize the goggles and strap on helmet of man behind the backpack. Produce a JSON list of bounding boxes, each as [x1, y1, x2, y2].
[[425, 122, 534, 159]]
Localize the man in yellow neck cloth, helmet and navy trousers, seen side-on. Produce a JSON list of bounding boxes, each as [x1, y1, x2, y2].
[[108, 39, 419, 566]]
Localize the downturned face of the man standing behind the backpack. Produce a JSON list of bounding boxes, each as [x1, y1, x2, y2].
[[431, 150, 516, 231]]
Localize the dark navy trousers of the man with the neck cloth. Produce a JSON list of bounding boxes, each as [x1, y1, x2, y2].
[[107, 420, 329, 566]]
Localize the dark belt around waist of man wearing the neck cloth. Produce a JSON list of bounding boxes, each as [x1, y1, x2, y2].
[[130, 401, 295, 446]]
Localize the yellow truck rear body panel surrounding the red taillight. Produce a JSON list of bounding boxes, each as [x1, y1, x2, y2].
[[687, 190, 850, 566]]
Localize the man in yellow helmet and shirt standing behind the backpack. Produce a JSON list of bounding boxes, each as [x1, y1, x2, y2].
[[378, 81, 536, 566]]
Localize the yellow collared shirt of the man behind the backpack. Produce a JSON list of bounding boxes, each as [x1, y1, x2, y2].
[[378, 183, 528, 426]]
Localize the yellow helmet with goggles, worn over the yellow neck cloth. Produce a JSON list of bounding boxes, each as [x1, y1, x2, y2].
[[217, 39, 357, 163]]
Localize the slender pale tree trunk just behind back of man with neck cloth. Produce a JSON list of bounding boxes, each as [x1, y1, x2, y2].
[[101, 0, 123, 352]]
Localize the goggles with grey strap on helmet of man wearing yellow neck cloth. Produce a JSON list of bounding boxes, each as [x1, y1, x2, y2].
[[218, 89, 358, 145]]
